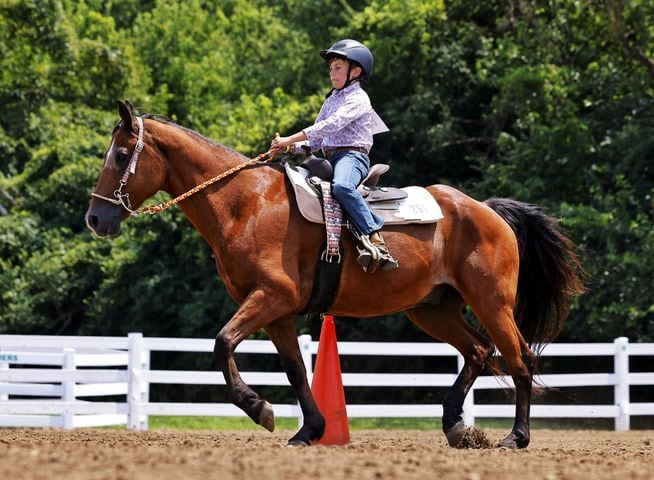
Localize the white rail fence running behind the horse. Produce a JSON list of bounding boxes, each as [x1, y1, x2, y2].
[[0, 333, 654, 430]]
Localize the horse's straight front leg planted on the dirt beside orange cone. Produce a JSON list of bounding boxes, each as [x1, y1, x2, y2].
[[265, 317, 325, 445]]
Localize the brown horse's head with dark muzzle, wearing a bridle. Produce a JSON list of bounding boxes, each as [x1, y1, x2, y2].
[[86, 101, 166, 237]]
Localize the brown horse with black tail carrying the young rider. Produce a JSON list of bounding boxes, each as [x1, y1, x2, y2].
[[86, 102, 583, 448]]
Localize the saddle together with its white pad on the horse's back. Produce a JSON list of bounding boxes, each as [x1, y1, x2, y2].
[[284, 157, 443, 225]]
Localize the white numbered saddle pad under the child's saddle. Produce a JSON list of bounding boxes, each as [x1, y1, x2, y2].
[[284, 163, 443, 225]]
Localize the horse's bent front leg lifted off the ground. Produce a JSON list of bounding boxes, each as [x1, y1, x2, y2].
[[214, 291, 282, 432]]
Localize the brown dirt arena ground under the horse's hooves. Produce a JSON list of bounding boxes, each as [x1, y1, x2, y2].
[[0, 429, 654, 480]]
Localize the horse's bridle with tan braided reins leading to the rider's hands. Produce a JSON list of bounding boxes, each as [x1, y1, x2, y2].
[[91, 117, 273, 216]]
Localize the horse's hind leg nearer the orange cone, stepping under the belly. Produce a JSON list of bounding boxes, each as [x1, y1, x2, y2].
[[406, 289, 493, 447]]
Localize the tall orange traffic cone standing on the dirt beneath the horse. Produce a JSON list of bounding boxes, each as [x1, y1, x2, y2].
[[311, 315, 350, 445]]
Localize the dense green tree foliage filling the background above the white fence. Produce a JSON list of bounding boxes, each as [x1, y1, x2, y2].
[[0, 0, 654, 341]]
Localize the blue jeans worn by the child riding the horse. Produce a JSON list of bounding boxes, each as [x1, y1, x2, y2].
[[328, 151, 384, 235]]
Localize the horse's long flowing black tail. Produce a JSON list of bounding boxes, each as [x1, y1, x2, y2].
[[485, 198, 585, 346]]
